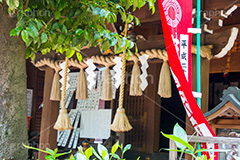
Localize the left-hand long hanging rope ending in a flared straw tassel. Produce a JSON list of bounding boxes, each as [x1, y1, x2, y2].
[[53, 57, 73, 131]]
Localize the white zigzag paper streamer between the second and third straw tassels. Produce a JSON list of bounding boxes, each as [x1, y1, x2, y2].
[[85, 59, 96, 90]]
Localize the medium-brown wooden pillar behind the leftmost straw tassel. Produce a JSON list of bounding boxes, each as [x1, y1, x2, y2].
[[38, 67, 59, 160]]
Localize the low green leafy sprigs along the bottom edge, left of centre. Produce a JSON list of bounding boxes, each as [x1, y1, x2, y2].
[[23, 142, 140, 160]]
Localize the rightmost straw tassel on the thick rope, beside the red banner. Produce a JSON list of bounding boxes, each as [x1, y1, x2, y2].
[[158, 60, 172, 98]]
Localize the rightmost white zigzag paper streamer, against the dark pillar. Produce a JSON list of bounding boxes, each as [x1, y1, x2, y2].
[[139, 54, 149, 91]]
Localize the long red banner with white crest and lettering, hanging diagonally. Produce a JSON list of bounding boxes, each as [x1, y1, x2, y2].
[[158, 0, 218, 160]]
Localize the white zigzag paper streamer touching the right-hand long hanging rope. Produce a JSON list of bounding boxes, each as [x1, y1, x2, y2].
[[113, 57, 122, 89]]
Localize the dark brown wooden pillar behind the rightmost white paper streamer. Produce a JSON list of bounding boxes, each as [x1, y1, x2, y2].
[[144, 63, 161, 153]]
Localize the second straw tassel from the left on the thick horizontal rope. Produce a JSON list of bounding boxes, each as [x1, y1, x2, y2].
[[76, 68, 88, 99]]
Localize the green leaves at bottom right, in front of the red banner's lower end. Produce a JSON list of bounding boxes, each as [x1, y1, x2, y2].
[[161, 124, 229, 160]]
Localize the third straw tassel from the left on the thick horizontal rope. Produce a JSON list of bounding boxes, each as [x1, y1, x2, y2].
[[101, 66, 112, 101]]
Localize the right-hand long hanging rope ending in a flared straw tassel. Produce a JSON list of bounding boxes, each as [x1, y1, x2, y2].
[[111, 23, 132, 132]]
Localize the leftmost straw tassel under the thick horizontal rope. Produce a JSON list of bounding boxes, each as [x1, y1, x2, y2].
[[50, 70, 61, 101]]
